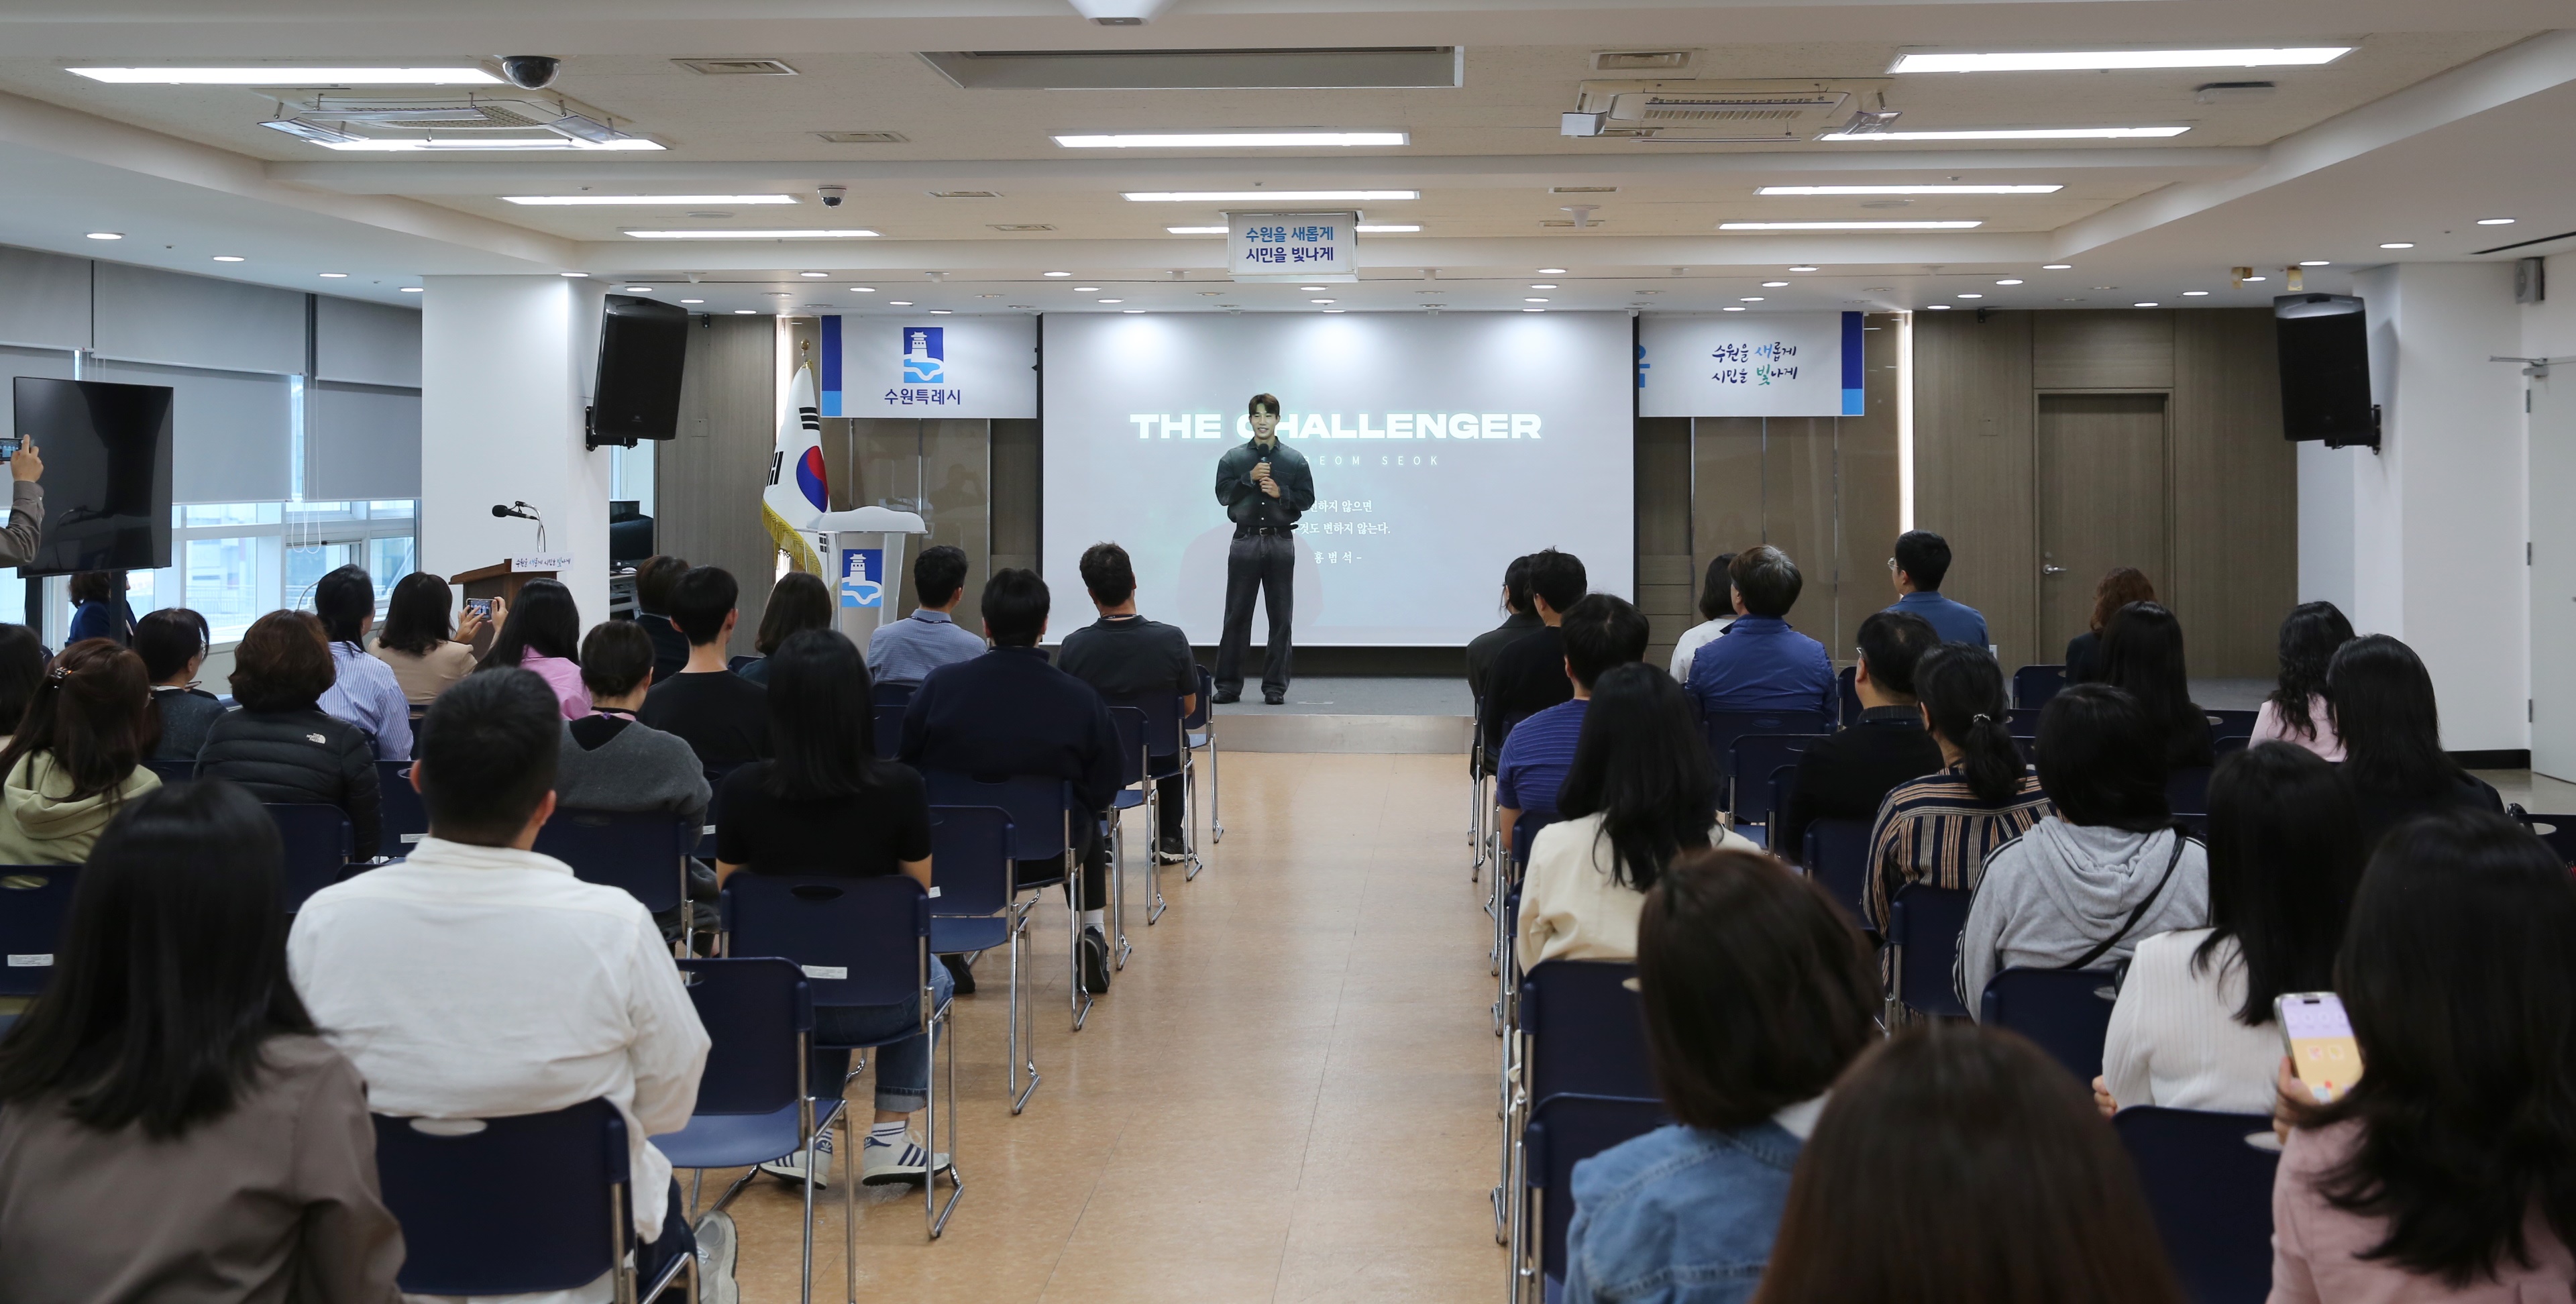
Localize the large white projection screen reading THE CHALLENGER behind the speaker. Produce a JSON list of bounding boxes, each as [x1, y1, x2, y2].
[[1040, 312, 1635, 647]]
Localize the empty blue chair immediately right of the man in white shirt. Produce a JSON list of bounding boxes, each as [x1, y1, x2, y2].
[[652, 959, 829, 1299]]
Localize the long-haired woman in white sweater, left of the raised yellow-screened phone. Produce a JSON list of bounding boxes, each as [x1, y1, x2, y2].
[[2094, 742, 2362, 1113]]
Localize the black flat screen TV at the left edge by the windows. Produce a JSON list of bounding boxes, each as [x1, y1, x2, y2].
[[0, 376, 175, 578]]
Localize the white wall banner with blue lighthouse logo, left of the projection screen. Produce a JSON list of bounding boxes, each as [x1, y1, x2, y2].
[[819, 312, 1038, 420]]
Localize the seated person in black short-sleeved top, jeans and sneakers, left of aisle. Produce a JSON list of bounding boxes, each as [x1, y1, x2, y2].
[[716, 629, 956, 1185]]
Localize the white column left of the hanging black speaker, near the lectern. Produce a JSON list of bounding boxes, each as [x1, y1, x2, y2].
[[420, 276, 608, 627]]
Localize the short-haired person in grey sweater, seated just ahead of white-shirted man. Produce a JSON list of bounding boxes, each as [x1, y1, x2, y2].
[[554, 621, 708, 824]]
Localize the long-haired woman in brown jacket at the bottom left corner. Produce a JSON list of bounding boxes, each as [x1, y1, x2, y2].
[[0, 783, 402, 1304]]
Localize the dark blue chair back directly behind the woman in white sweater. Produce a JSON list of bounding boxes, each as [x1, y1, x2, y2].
[[2110, 1105, 2279, 1304]]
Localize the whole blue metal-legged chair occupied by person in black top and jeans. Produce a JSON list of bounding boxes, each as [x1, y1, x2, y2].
[[721, 873, 966, 1237]]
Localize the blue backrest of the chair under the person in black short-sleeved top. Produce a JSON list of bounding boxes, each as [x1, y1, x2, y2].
[[721, 873, 930, 1005]]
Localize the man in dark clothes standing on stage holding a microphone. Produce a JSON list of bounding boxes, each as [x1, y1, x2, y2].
[[1216, 394, 1313, 706]]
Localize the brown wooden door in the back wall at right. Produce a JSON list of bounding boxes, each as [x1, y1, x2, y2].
[[2037, 394, 2171, 662]]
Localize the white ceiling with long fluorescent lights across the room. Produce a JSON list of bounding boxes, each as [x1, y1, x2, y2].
[[0, 0, 2576, 312]]
